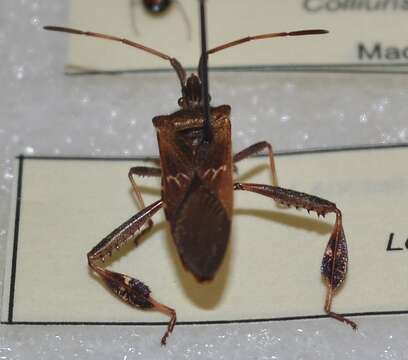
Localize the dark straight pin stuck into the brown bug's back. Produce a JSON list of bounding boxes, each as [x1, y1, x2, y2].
[[199, 0, 212, 143]]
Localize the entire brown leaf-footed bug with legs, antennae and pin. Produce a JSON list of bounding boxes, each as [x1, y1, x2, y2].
[[45, 0, 357, 345]]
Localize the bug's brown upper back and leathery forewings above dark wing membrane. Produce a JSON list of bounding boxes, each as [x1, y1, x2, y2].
[[153, 105, 232, 214]]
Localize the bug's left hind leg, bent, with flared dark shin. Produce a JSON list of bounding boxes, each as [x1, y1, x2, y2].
[[87, 200, 176, 345]]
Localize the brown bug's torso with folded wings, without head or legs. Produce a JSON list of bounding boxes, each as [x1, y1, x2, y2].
[[153, 105, 233, 281]]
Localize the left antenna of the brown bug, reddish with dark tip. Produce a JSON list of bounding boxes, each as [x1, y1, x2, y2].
[[44, 26, 186, 88]]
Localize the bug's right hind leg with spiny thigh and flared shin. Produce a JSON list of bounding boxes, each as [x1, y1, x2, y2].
[[234, 183, 357, 329]]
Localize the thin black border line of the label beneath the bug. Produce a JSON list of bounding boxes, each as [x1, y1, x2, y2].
[[4, 143, 408, 326]]
